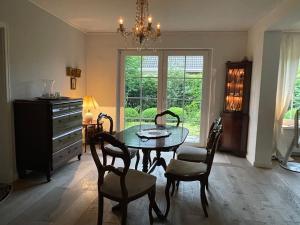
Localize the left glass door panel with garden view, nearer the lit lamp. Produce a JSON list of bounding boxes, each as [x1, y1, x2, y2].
[[121, 52, 161, 128]]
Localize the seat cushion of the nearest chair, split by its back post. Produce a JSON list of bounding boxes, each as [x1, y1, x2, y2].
[[101, 168, 156, 198]]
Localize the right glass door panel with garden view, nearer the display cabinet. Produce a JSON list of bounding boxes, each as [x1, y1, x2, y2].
[[164, 52, 204, 143]]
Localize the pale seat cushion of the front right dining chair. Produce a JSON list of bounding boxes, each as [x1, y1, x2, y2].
[[166, 159, 207, 177]]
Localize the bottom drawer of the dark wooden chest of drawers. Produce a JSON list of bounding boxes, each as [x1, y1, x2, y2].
[[52, 140, 82, 169]]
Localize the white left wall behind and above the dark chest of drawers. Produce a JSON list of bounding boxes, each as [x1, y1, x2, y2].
[[0, 0, 86, 182]]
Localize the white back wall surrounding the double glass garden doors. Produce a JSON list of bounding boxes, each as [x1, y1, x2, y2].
[[87, 32, 247, 130]]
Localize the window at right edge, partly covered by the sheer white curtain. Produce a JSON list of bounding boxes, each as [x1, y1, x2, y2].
[[283, 62, 300, 126]]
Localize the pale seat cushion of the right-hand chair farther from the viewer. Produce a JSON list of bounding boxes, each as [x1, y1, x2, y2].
[[176, 146, 207, 162]]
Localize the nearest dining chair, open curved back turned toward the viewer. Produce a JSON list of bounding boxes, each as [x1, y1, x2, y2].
[[90, 132, 156, 225]]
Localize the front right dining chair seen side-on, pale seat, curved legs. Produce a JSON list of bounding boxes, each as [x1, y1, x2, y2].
[[165, 125, 223, 217]]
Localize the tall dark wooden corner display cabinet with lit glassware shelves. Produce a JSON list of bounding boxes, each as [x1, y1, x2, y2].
[[220, 60, 252, 157]]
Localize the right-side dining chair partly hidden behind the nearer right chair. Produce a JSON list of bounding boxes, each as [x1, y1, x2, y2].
[[172, 117, 222, 192]]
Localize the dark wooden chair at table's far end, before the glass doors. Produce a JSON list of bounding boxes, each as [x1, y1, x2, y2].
[[149, 110, 180, 172]]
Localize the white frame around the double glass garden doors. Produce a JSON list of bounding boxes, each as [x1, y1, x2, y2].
[[116, 48, 215, 146]]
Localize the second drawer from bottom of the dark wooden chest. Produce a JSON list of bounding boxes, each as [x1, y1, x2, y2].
[[53, 127, 82, 153]]
